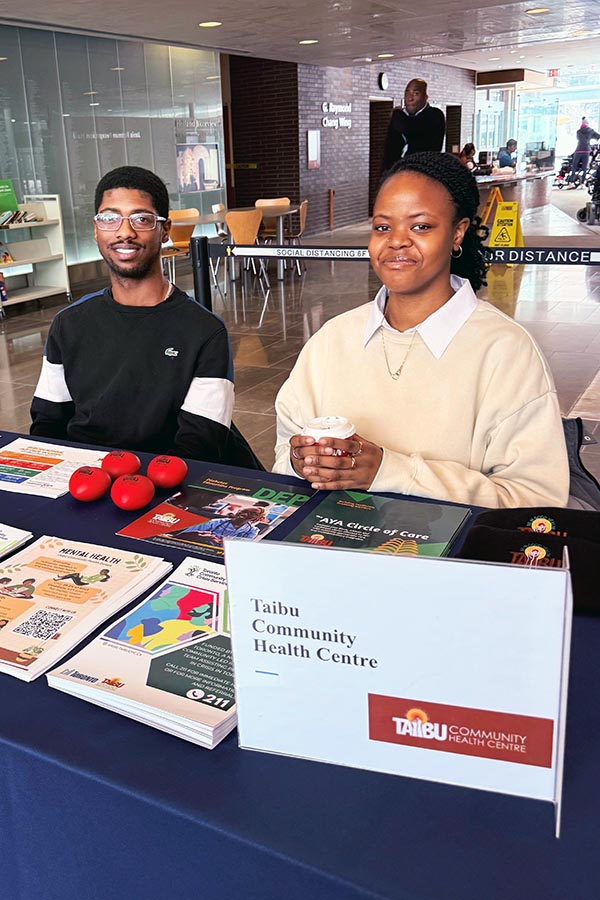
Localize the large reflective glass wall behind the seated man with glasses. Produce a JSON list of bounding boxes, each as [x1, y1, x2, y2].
[[0, 26, 225, 263]]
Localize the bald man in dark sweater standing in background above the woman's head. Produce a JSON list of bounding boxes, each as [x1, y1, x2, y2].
[[383, 78, 446, 172]]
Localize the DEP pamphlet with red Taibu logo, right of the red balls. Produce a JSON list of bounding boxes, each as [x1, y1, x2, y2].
[[118, 472, 314, 559]]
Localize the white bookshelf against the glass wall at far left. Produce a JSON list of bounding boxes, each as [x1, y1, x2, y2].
[[0, 194, 71, 307]]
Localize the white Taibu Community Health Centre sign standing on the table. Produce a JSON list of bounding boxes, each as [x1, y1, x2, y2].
[[225, 540, 572, 836]]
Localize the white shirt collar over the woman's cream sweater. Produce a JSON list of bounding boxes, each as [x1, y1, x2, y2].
[[363, 275, 478, 359]]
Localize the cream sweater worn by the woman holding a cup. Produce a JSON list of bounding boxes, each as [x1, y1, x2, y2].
[[273, 300, 569, 507]]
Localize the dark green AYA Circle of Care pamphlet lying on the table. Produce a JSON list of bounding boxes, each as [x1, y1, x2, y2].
[[284, 491, 471, 556]]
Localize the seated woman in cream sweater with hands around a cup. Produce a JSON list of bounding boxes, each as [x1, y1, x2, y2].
[[274, 153, 569, 507]]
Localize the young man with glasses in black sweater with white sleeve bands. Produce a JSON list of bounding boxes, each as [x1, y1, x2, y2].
[[31, 166, 233, 462]]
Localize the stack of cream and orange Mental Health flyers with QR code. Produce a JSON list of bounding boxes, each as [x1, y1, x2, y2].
[[0, 535, 172, 681]]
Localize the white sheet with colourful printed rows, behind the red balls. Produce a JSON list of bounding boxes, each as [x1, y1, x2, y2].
[[0, 438, 106, 498]]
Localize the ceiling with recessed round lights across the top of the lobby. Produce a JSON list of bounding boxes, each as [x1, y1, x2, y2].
[[0, 0, 600, 71]]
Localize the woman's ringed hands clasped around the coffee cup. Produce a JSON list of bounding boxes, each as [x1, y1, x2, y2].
[[290, 434, 383, 491]]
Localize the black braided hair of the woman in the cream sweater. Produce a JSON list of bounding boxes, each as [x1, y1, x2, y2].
[[381, 151, 489, 291]]
